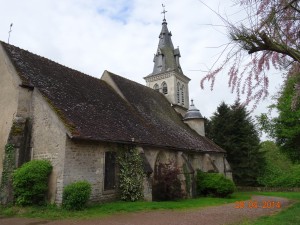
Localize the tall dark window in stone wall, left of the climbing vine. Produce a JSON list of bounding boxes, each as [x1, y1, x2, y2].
[[104, 152, 116, 191]]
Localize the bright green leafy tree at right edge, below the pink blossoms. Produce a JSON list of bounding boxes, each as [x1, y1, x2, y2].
[[258, 68, 300, 163]]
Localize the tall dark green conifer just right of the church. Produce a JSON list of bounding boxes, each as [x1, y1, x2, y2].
[[211, 102, 264, 186]]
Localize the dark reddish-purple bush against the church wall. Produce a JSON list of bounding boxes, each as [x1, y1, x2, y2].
[[153, 164, 183, 201]]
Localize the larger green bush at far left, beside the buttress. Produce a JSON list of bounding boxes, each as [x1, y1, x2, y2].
[[13, 160, 52, 205]]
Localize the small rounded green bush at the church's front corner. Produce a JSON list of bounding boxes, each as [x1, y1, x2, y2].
[[62, 181, 92, 210]]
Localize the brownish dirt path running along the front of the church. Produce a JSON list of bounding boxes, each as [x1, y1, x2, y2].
[[0, 196, 291, 225]]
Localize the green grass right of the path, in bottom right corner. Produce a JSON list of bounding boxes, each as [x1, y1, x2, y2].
[[237, 192, 300, 225]]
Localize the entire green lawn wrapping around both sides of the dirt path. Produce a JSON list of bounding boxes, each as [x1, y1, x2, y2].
[[0, 192, 300, 222]]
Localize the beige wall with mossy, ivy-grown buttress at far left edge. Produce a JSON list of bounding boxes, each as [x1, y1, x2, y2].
[[0, 45, 32, 204]]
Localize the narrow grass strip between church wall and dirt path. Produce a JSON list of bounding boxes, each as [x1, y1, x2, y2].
[[0, 192, 251, 219]]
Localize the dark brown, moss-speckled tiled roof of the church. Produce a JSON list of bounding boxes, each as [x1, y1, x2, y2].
[[0, 42, 224, 152]]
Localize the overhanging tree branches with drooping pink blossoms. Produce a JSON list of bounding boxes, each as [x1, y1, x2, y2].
[[201, 0, 300, 107]]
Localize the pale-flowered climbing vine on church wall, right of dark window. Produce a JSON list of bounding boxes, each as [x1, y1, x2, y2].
[[117, 145, 144, 201]]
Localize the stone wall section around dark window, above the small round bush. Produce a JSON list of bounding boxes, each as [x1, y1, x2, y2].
[[64, 140, 117, 202]]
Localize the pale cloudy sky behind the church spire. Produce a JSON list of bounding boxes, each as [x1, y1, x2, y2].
[[0, 0, 281, 117]]
